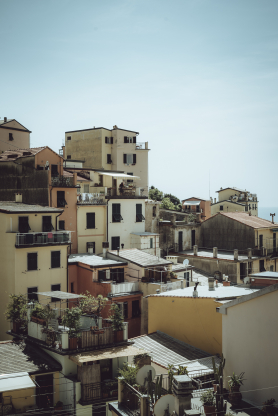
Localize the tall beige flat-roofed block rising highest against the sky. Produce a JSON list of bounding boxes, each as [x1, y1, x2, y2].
[[64, 126, 149, 191]]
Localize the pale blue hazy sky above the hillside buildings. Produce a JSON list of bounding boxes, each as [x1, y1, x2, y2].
[[0, 0, 278, 207]]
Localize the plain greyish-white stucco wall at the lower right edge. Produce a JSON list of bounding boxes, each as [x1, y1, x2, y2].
[[222, 290, 278, 405]]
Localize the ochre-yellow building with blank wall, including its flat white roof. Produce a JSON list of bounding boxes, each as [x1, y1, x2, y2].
[[148, 285, 260, 354]]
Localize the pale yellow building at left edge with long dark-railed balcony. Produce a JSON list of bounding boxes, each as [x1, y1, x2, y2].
[[0, 202, 71, 340]]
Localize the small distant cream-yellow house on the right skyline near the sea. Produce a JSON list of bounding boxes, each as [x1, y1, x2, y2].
[[211, 188, 258, 217]]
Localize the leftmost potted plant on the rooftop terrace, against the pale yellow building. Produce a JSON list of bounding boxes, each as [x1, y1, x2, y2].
[[5, 295, 27, 334]]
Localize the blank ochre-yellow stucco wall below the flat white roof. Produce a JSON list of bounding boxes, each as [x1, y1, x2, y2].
[[148, 296, 222, 354]]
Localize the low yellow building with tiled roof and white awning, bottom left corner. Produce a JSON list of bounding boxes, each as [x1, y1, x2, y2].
[[0, 341, 62, 414]]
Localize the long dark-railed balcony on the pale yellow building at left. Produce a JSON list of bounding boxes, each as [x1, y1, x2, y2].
[[15, 231, 71, 247]]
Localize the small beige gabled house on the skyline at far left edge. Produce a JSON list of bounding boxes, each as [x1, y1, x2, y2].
[[0, 117, 32, 153]]
